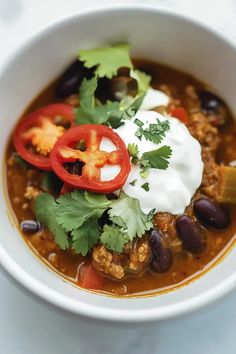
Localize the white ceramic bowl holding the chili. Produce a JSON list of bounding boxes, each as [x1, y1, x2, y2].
[[0, 6, 236, 322]]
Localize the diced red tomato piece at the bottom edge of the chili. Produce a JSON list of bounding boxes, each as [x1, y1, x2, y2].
[[80, 265, 103, 290]]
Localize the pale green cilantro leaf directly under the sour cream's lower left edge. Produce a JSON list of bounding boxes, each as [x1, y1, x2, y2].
[[108, 192, 153, 241]]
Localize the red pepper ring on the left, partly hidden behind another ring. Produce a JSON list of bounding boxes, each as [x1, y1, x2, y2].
[[13, 103, 75, 171]]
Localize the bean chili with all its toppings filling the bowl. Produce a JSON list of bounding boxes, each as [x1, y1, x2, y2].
[[6, 46, 236, 296]]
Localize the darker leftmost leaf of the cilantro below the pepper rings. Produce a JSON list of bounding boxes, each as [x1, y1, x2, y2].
[[35, 193, 69, 250]]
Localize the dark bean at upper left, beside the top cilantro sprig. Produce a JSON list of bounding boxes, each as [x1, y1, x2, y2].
[[56, 60, 92, 98]]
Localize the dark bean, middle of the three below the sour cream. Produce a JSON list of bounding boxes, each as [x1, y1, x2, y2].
[[176, 215, 206, 253]]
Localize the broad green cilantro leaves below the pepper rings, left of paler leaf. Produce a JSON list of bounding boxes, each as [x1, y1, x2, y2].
[[35, 191, 110, 256]]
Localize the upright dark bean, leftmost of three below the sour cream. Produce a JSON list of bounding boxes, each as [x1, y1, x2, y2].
[[149, 229, 172, 273]]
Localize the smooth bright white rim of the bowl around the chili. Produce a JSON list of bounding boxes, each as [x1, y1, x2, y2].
[[0, 4, 236, 322]]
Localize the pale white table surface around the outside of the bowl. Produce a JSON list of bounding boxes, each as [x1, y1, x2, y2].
[[0, 0, 236, 354]]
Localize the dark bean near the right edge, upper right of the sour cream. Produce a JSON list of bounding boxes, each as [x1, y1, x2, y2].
[[198, 90, 229, 126]]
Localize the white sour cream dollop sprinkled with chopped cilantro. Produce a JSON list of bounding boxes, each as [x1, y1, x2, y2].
[[100, 111, 203, 214]]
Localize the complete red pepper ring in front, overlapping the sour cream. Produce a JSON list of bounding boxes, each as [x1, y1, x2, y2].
[[50, 124, 130, 193]]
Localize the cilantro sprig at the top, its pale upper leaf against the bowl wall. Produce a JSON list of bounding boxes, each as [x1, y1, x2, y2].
[[75, 43, 151, 128]]
